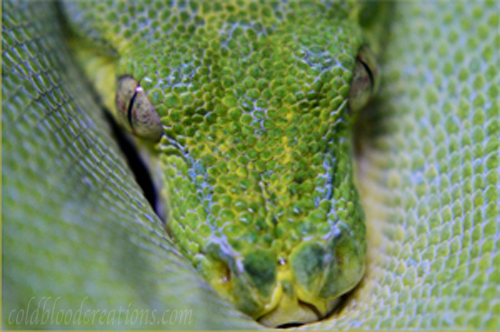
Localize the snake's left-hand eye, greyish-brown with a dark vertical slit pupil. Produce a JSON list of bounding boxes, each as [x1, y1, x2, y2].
[[115, 75, 163, 142]]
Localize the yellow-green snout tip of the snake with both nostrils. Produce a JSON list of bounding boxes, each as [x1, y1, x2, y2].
[[199, 223, 365, 326]]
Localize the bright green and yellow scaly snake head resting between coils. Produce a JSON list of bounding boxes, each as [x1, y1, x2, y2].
[[60, 1, 366, 325]]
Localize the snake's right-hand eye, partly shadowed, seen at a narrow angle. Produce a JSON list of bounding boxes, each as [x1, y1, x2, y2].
[[349, 47, 378, 112]]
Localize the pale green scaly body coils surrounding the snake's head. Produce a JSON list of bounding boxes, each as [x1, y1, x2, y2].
[[1, 0, 500, 330]]
